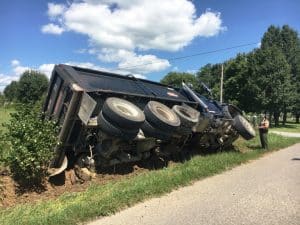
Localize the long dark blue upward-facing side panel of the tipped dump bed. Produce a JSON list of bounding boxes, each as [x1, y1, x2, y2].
[[51, 64, 189, 102]]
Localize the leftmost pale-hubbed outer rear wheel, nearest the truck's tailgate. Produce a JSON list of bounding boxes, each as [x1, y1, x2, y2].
[[102, 97, 145, 129]]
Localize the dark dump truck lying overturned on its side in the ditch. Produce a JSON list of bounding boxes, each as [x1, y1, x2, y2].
[[43, 65, 255, 175]]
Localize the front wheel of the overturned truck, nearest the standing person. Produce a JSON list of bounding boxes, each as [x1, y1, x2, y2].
[[233, 115, 255, 140]]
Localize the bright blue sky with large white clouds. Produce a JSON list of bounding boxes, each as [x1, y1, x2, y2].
[[0, 0, 300, 91]]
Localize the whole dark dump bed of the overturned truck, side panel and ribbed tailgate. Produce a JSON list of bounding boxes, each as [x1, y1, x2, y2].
[[43, 64, 197, 122]]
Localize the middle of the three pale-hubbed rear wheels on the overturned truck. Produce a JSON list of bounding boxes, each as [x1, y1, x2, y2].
[[144, 101, 180, 132]]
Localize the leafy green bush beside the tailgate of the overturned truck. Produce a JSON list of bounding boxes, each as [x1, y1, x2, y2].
[[4, 105, 58, 185]]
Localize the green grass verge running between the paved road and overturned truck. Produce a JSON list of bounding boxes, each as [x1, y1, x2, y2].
[[0, 134, 300, 225]]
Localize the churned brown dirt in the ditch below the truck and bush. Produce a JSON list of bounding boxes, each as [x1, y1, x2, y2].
[[0, 165, 148, 208]]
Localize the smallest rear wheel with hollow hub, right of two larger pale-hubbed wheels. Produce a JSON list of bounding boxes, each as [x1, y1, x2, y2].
[[172, 105, 200, 127]]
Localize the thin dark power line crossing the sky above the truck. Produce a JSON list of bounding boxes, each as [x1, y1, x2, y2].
[[118, 42, 259, 70]]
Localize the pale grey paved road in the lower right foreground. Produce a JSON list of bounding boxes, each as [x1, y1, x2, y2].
[[90, 144, 300, 225]]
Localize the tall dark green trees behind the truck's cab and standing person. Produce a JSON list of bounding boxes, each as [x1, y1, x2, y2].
[[161, 25, 300, 126]]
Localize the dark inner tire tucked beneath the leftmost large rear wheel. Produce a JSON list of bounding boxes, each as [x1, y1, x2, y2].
[[98, 111, 139, 140]]
